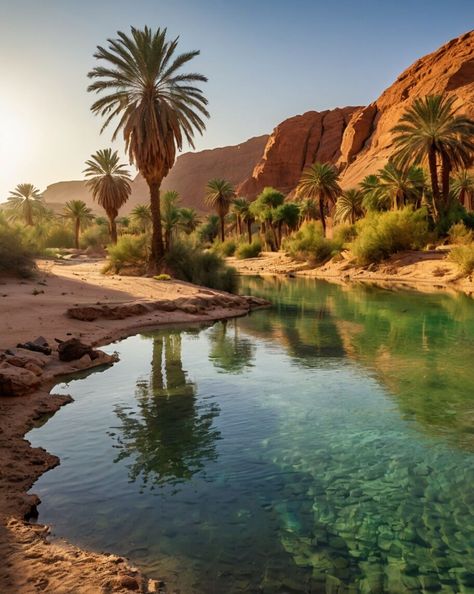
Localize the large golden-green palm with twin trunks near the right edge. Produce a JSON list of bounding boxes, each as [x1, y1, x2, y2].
[[392, 95, 474, 208]]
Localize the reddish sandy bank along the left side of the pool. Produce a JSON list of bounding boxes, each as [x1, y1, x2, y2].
[[0, 261, 268, 594]]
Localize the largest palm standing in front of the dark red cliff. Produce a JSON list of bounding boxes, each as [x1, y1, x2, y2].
[[296, 162, 342, 235]]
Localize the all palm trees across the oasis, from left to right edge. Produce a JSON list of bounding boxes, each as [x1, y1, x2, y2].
[[3, 22, 474, 269]]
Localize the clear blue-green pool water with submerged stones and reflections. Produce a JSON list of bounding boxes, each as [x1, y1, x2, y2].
[[28, 279, 474, 594]]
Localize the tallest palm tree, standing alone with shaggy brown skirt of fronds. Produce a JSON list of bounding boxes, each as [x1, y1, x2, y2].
[[88, 27, 209, 267]]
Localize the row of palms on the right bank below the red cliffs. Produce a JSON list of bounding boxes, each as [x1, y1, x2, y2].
[[206, 95, 474, 249]]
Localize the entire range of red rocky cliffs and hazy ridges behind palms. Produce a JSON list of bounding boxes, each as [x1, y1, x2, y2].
[[44, 31, 474, 214]]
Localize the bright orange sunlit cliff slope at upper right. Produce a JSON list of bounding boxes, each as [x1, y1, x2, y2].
[[338, 31, 474, 188]]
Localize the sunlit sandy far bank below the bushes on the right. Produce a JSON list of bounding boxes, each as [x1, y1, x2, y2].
[[228, 250, 474, 295]]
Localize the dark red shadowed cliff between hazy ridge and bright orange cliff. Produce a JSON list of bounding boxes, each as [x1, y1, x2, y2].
[[238, 107, 361, 199]]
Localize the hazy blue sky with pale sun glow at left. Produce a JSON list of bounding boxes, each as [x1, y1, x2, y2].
[[0, 0, 474, 201]]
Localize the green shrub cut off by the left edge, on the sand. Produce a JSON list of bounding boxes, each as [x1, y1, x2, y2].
[[0, 221, 36, 278]]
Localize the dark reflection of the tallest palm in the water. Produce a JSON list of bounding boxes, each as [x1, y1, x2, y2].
[[111, 332, 220, 486]]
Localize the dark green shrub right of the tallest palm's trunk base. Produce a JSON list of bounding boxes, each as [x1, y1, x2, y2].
[[165, 239, 237, 292]]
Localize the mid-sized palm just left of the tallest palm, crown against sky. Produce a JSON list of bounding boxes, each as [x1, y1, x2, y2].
[[84, 148, 132, 243]]
